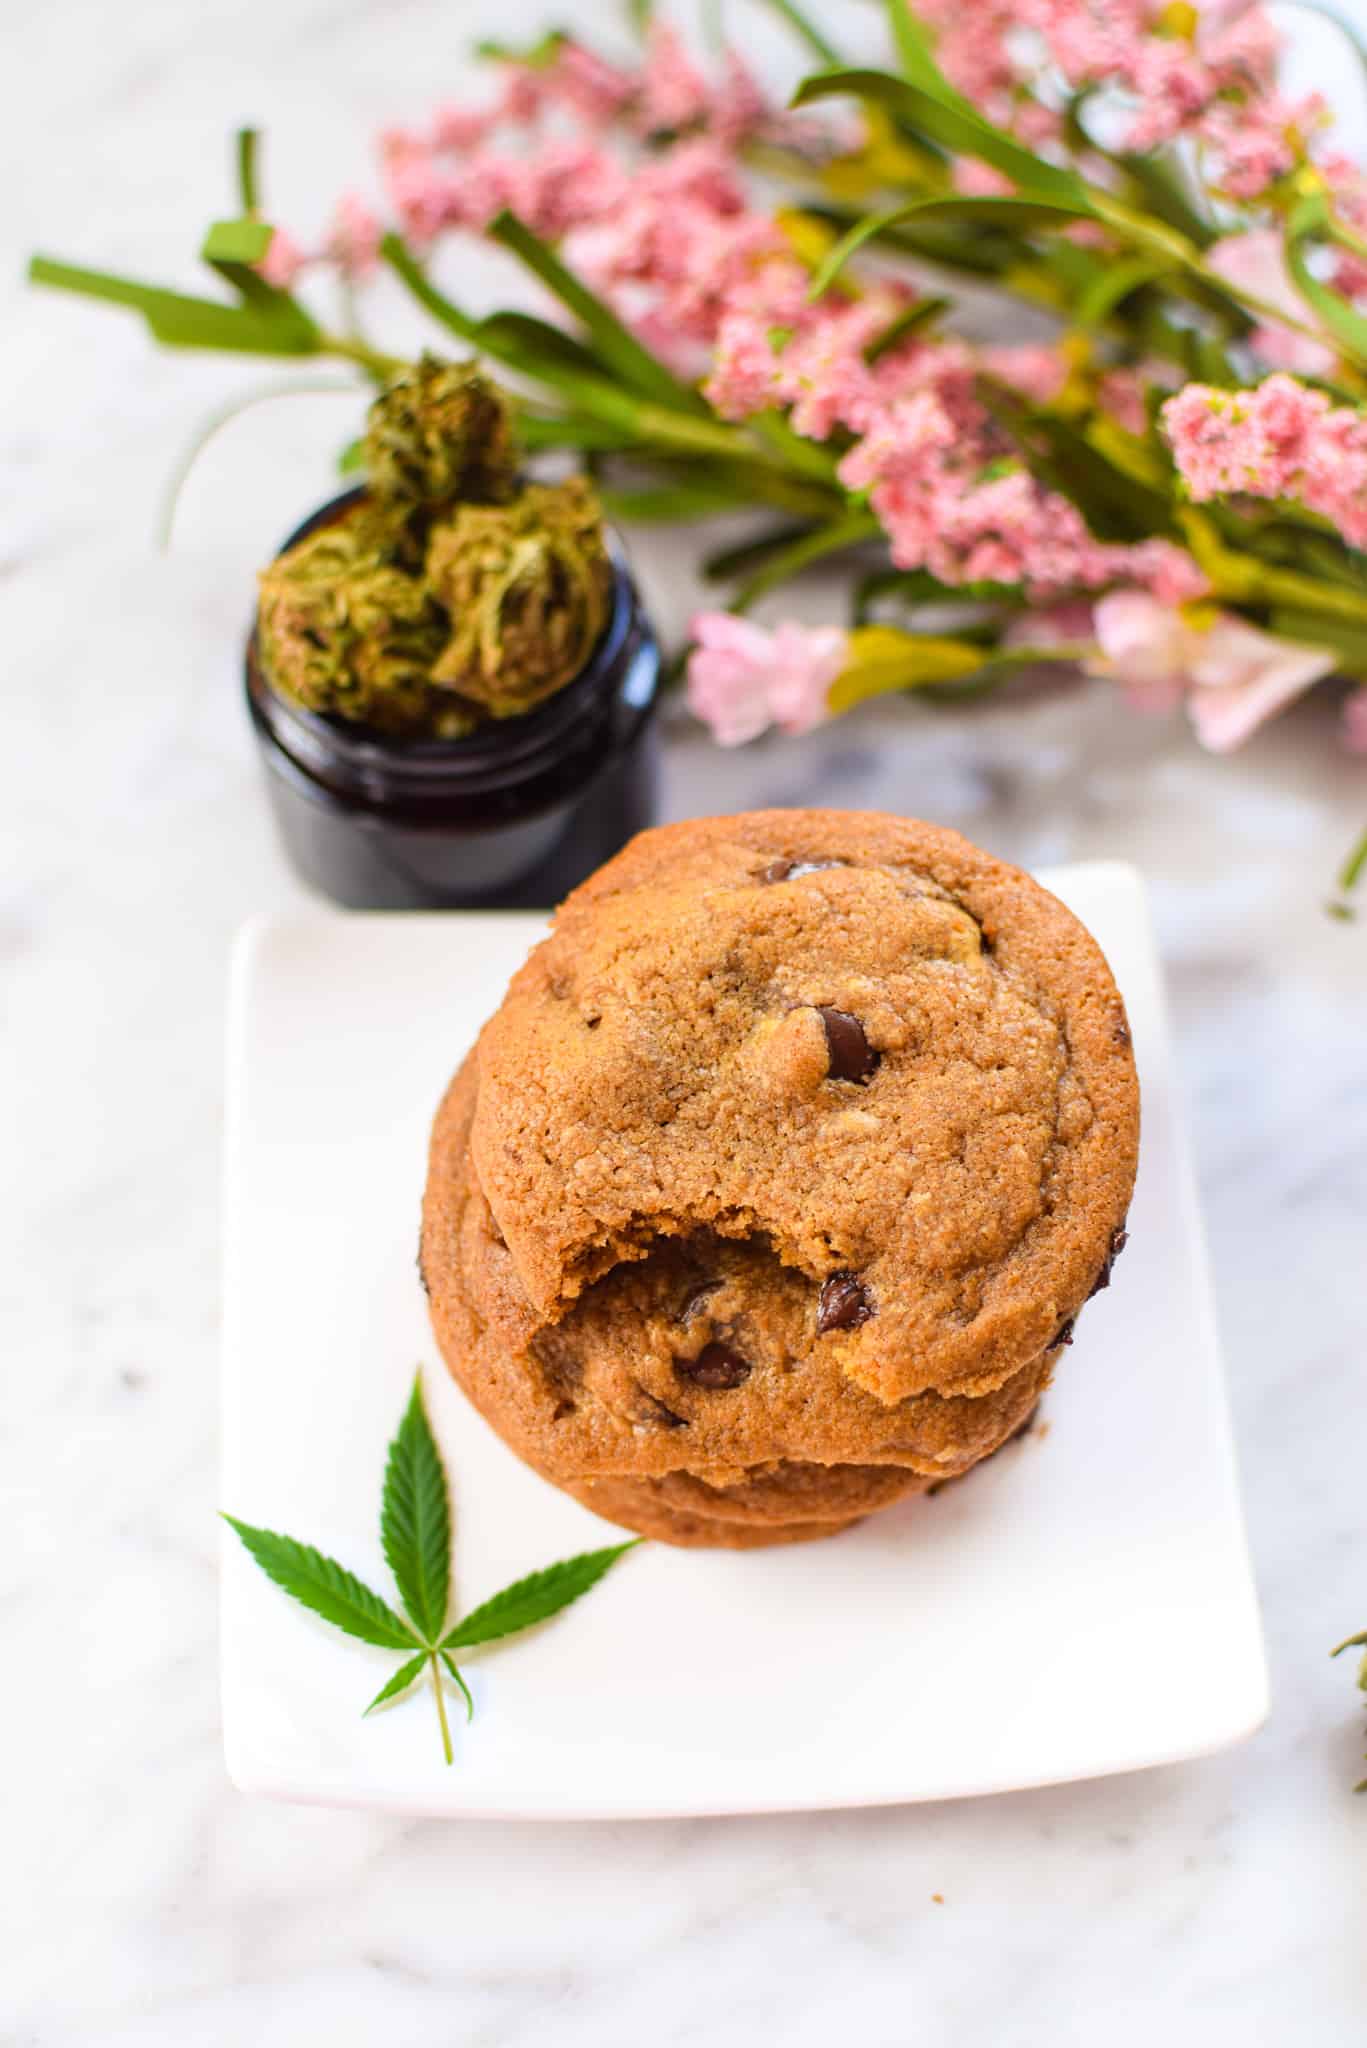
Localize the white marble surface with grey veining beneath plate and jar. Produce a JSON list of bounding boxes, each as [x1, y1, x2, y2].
[[0, 0, 1367, 2048]]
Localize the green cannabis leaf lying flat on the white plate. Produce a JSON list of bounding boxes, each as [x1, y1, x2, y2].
[[223, 1376, 639, 1763]]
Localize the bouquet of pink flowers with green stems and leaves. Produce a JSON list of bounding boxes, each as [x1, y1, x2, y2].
[[33, 0, 1367, 909]]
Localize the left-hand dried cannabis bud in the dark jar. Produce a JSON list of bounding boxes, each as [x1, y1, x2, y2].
[[258, 500, 475, 739]]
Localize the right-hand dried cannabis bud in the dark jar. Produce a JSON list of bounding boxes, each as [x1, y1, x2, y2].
[[426, 477, 613, 719]]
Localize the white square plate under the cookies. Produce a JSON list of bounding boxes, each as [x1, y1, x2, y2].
[[223, 864, 1267, 1819]]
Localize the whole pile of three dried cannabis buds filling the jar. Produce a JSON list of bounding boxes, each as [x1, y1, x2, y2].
[[256, 356, 613, 739]]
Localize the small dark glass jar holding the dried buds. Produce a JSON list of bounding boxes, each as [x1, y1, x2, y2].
[[246, 492, 660, 909]]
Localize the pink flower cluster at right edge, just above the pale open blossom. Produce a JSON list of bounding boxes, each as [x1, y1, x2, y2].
[[1162, 373, 1367, 547]]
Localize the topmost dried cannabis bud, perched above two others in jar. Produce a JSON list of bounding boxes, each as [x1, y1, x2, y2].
[[365, 356, 516, 516]]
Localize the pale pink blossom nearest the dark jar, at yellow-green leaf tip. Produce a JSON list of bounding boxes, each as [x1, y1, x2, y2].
[[689, 612, 844, 748]]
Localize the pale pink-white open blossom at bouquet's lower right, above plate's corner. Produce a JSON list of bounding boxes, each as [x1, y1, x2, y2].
[[1088, 592, 1334, 754]]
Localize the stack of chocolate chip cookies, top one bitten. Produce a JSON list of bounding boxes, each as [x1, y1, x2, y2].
[[420, 811, 1140, 1546]]
